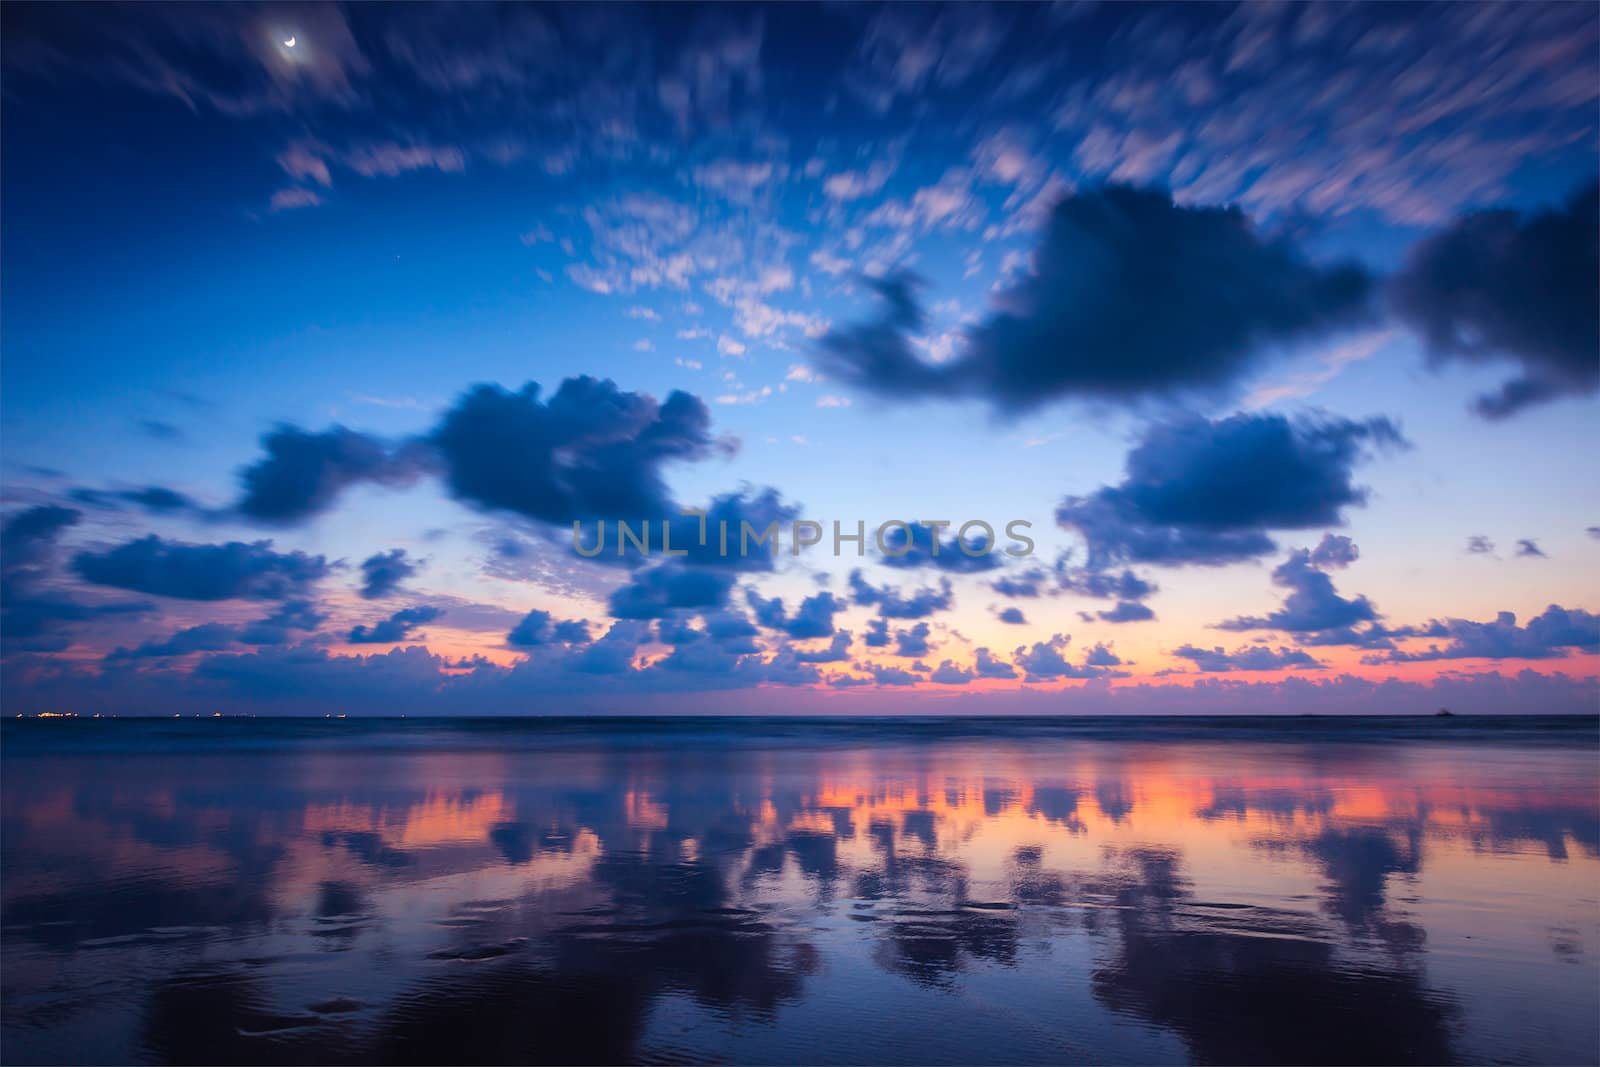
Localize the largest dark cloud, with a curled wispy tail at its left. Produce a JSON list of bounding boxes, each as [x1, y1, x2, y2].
[[818, 186, 1373, 411]]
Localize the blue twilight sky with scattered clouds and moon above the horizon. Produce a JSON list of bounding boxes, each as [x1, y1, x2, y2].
[[0, 3, 1600, 715]]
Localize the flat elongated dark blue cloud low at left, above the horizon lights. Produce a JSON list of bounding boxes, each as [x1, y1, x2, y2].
[[72, 534, 331, 600]]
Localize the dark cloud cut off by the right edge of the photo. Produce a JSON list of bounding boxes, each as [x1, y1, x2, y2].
[[1390, 182, 1600, 419]]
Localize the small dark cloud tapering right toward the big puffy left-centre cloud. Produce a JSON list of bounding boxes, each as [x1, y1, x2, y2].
[[235, 426, 430, 525]]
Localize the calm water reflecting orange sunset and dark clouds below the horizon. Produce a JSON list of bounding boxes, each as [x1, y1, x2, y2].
[[0, 723, 1600, 1062]]
